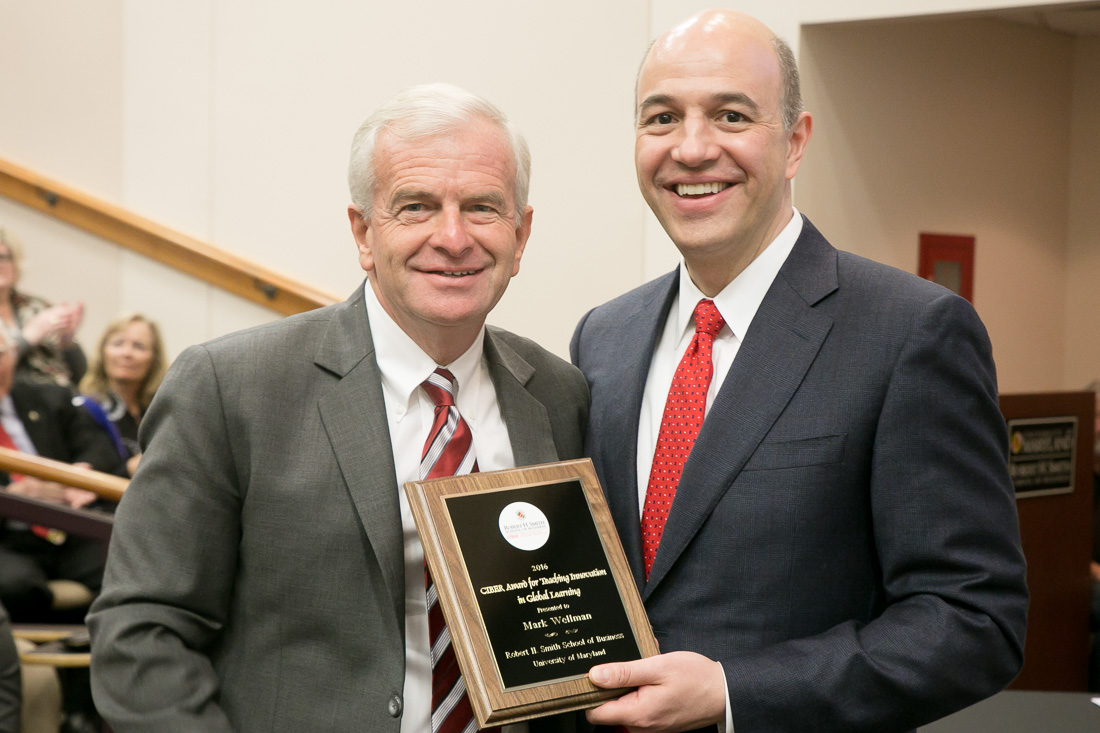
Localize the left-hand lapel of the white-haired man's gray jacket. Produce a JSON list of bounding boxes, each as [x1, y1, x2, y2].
[[315, 288, 405, 628]]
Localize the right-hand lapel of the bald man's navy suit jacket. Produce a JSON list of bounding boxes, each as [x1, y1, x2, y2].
[[645, 221, 837, 597]]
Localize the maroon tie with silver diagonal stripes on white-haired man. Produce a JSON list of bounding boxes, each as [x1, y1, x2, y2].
[[420, 369, 492, 733]]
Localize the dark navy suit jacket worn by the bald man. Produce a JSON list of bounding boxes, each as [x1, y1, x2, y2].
[[572, 216, 1027, 733]]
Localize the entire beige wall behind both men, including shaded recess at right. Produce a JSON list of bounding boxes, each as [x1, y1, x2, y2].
[[0, 0, 1100, 390]]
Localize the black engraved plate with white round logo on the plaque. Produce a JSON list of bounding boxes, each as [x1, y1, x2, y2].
[[444, 480, 641, 690]]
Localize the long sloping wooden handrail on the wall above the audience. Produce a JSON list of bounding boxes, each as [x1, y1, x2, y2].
[[0, 158, 342, 316]]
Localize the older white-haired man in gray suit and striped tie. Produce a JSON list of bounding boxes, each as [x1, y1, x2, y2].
[[88, 85, 587, 733]]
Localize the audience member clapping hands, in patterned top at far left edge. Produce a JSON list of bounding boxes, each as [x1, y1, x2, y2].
[[0, 229, 88, 391]]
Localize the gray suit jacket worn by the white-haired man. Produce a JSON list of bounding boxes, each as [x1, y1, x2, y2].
[[88, 288, 587, 733]]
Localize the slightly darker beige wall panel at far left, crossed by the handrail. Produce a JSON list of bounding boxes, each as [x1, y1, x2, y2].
[[0, 0, 124, 356]]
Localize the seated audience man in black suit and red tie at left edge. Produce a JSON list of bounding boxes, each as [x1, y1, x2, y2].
[[0, 325, 125, 621]]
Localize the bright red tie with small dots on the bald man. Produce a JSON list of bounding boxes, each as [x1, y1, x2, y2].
[[641, 299, 726, 580]]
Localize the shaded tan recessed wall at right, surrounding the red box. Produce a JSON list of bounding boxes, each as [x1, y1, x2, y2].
[[798, 20, 1073, 392]]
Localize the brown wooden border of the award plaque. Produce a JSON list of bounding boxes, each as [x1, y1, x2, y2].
[[405, 458, 658, 727]]
